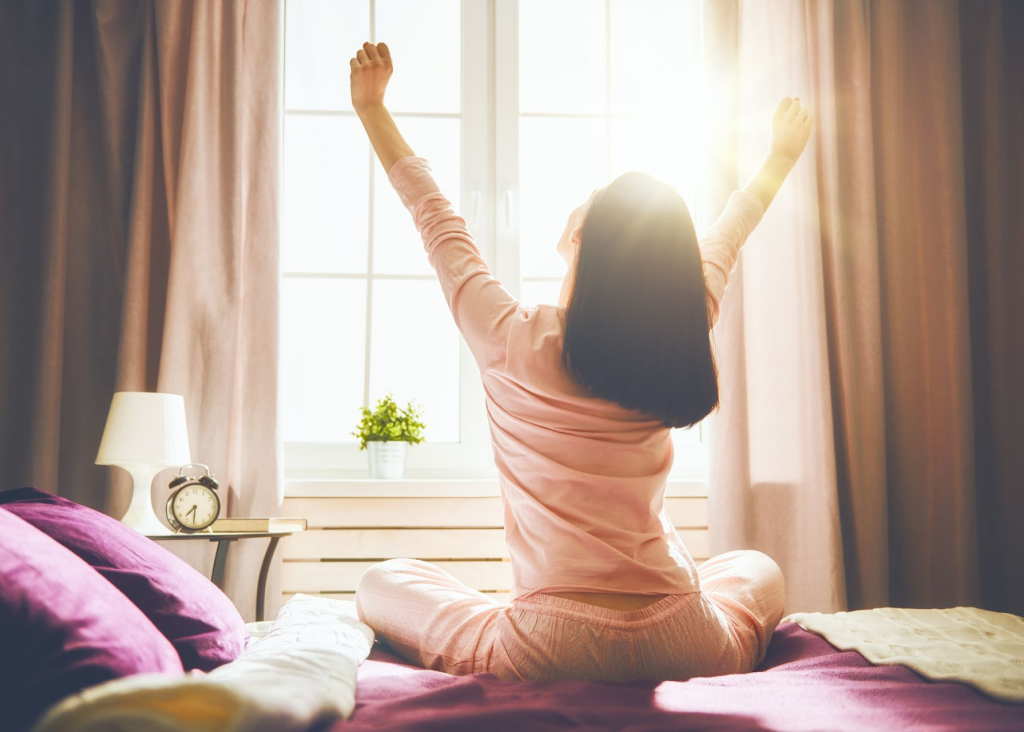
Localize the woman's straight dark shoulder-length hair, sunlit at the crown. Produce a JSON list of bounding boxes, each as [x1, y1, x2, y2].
[[562, 173, 718, 427]]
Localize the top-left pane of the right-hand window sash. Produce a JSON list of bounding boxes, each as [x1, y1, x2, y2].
[[519, 0, 607, 115]]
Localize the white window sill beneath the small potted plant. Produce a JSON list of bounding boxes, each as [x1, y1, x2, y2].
[[285, 478, 708, 499]]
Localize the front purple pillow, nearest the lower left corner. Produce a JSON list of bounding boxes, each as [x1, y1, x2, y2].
[[0, 509, 182, 730]]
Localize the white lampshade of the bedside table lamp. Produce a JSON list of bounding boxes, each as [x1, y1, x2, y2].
[[96, 391, 191, 468]]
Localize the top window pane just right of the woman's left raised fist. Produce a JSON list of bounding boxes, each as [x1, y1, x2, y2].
[[374, 0, 462, 113]]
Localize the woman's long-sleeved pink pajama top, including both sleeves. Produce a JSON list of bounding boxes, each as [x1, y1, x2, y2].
[[388, 157, 764, 599]]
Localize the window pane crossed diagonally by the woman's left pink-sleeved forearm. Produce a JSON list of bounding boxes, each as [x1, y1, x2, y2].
[[374, 117, 462, 274]]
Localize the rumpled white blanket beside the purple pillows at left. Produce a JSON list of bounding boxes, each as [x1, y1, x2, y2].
[[35, 595, 374, 732]]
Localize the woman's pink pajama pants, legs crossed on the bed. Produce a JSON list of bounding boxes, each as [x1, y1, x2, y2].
[[355, 551, 784, 681]]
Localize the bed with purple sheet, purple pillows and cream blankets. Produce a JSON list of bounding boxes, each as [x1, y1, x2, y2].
[[0, 488, 1024, 732]]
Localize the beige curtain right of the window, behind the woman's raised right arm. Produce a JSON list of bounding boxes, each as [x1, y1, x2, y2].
[[706, 0, 1024, 612]]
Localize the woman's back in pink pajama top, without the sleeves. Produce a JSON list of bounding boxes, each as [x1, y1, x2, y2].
[[482, 305, 697, 598]]
